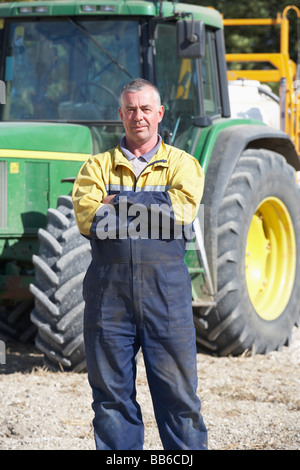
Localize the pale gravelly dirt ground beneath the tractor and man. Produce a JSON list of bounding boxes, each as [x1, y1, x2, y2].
[[0, 329, 300, 450]]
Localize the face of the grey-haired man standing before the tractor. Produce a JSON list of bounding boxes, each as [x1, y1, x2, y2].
[[119, 86, 164, 145]]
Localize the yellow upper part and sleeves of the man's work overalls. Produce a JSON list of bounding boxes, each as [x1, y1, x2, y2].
[[73, 138, 204, 238]]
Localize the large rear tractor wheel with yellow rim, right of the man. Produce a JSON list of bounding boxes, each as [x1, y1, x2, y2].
[[195, 149, 300, 356]]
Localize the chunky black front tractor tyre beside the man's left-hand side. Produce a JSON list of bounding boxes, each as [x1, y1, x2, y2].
[[30, 196, 91, 372]]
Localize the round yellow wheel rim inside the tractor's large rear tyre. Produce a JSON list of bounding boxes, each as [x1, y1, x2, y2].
[[245, 197, 296, 321]]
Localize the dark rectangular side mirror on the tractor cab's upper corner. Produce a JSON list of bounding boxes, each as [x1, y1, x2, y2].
[[177, 20, 205, 59]]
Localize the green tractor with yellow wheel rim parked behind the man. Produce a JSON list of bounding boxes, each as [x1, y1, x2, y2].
[[0, 0, 300, 371]]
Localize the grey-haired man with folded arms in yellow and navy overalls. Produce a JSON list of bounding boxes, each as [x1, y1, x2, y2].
[[73, 79, 207, 450]]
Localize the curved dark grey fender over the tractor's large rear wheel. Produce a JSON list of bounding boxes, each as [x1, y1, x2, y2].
[[201, 124, 300, 291]]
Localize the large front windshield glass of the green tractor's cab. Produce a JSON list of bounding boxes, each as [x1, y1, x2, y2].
[[1, 19, 141, 121]]
